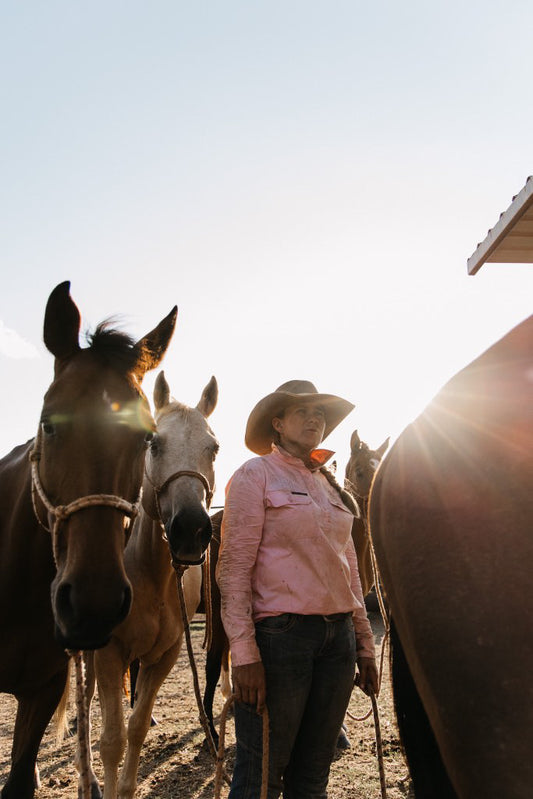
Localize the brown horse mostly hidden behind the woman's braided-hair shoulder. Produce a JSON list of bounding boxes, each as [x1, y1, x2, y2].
[[344, 430, 389, 596]]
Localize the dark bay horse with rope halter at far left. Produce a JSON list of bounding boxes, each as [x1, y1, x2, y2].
[[0, 282, 177, 799]]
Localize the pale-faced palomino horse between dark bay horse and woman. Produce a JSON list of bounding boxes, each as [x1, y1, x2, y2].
[[89, 373, 218, 799]]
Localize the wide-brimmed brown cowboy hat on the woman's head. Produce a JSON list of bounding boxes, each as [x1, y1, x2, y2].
[[244, 380, 355, 455]]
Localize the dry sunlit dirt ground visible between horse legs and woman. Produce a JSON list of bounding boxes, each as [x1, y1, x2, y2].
[[0, 612, 412, 799]]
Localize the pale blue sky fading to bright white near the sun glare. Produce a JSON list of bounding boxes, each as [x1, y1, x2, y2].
[[0, 0, 533, 504]]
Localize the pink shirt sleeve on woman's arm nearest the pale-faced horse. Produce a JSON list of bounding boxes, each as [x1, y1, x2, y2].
[[216, 461, 265, 666]]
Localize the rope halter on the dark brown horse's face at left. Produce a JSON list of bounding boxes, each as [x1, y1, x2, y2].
[[29, 432, 142, 563]]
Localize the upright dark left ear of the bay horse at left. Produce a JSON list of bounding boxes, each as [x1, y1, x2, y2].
[[43, 280, 81, 361]]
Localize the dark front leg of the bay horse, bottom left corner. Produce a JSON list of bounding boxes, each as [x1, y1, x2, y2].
[[1, 663, 67, 799]]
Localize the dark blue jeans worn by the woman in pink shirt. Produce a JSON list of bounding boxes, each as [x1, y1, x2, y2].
[[229, 613, 356, 799]]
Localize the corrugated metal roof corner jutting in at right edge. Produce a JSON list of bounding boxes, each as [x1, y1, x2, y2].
[[467, 175, 533, 275]]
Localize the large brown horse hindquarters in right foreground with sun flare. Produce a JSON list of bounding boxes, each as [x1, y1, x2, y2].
[[370, 316, 533, 799]]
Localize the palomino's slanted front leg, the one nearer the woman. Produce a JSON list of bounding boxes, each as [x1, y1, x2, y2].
[[115, 637, 182, 799]]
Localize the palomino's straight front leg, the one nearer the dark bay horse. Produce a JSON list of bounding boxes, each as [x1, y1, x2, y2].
[[94, 640, 127, 799]]
